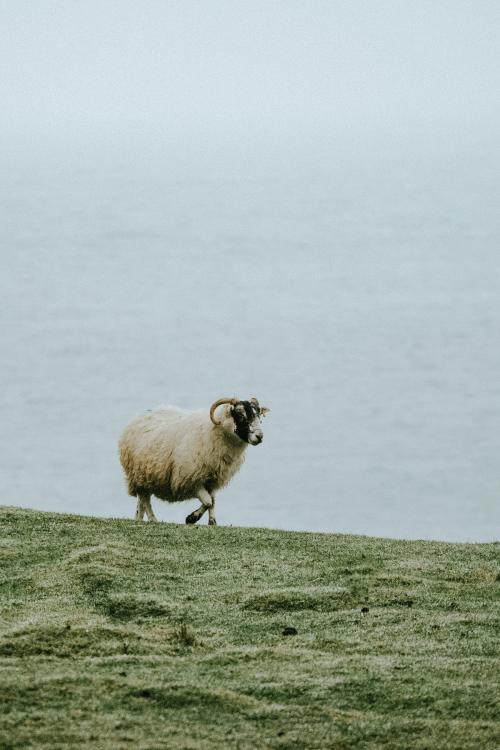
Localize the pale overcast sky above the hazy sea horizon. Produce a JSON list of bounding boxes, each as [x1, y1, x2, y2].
[[0, 0, 500, 156]]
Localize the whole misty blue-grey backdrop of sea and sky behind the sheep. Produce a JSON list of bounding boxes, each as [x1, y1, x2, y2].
[[0, 0, 500, 541]]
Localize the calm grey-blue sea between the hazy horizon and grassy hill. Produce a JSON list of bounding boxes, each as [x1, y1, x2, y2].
[[0, 145, 500, 541]]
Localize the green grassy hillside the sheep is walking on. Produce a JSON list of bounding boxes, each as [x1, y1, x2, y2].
[[0, 508, 500, 750]]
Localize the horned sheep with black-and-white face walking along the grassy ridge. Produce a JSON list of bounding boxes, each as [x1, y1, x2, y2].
[[119, 398, 269, 525]]
